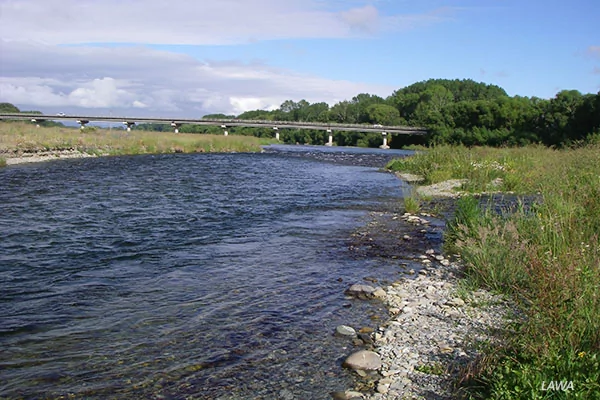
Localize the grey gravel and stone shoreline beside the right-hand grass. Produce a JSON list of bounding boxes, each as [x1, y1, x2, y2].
[[332, 179, 514, 400]]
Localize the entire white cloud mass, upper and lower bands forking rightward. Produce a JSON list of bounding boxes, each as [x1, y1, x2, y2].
[[0, 0, 444, 116]]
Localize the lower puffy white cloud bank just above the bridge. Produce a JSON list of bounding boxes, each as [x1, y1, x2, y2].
[[0, 41, 396, 116]]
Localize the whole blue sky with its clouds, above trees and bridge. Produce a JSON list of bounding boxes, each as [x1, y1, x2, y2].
[[0, 0, 600, 118]]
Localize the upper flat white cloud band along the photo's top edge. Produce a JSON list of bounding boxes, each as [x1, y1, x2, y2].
[[0, 0, 450, 45]]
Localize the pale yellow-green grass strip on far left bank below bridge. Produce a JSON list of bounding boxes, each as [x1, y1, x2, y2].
[[0, 122, 261, 165]]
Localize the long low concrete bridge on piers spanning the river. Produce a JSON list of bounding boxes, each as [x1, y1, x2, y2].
[[0, 113, 427, 148]]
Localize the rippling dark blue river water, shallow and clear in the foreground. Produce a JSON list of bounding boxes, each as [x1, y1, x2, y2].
[[0, 146, 414, 399]]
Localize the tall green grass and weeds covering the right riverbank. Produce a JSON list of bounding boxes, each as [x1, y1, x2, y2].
[[388, 143, 600, 399]]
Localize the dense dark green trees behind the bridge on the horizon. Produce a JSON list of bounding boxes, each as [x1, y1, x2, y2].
[[2, 79, 600, 147]]
